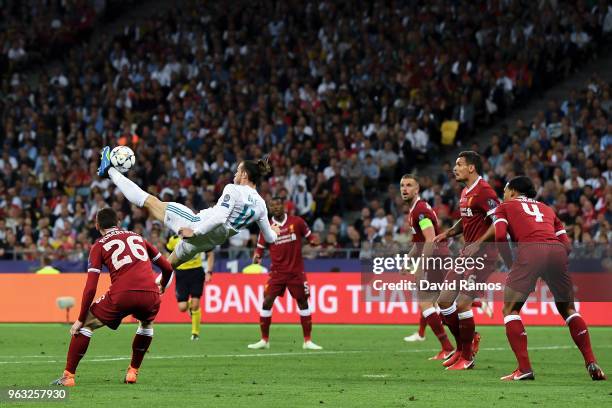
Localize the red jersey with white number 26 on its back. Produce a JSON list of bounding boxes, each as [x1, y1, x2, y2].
[[87, 228, 161, 293]]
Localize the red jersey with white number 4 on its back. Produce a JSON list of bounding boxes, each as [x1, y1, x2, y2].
[[495, 197, 565, 242]]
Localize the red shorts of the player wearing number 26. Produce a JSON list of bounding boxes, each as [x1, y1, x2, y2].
[[89, 290, 161, 330]]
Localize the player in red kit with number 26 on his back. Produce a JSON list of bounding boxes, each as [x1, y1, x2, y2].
[[52, 208, 172, 386]]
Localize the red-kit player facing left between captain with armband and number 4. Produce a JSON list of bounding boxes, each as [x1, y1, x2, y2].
[[434, 151, 499, 370]]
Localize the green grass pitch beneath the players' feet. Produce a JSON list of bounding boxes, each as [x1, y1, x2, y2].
[[0, 324, 612, 408]]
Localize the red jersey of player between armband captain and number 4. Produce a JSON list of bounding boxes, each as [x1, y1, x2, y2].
[[459, 177, 499, 243]]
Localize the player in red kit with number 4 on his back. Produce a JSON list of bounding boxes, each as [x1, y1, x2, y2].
[[494, 176, 606, 381]]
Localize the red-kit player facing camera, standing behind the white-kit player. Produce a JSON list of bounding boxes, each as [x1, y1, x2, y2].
[[248, 197, 322, 350]]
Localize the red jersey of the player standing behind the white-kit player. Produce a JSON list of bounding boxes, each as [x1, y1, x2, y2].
[[255, 215, 312, 279]]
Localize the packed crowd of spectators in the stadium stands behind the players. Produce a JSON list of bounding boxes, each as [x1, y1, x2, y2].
[[0, 0, 612, 260]]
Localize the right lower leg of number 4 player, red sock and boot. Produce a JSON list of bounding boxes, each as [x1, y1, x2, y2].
[[556, 302, 607, 381]]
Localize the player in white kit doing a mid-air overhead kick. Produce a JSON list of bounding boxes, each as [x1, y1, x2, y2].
[[98, 146, 279, 267]]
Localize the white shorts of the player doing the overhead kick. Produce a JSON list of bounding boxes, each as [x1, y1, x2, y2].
[[164, 203, 237, 263]]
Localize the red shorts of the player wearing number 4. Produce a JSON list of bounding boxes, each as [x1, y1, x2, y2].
[[506, 244, 574, 302]]
